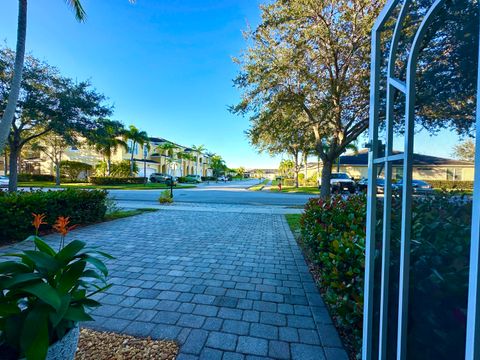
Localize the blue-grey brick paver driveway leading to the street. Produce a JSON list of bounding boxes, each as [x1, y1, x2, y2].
[[5, 210, 346, 360]]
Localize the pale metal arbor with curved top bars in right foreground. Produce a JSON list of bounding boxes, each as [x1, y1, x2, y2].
[[362, 0, 480, 360]]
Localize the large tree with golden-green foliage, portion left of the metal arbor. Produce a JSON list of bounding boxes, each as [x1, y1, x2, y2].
[[233, 0, 383, 197]]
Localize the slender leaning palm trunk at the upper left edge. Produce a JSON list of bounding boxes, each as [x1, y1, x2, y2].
[[0, 0, 27, 153]]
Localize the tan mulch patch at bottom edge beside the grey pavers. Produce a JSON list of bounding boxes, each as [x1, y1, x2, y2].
[[75, 329, 179, 360]]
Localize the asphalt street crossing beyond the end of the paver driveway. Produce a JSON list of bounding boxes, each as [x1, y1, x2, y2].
[[109, 180, 313, 206]]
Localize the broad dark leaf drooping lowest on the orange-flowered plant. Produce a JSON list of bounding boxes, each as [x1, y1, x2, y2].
[[20, 306, 49, 360]]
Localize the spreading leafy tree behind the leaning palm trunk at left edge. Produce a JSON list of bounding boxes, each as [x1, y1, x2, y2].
[[0, 48, 111, 191]]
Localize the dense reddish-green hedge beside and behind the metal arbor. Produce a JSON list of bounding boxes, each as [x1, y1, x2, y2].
[[301, 194, 472, 359]]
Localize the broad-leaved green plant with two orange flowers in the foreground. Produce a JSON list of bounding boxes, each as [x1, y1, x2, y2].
[[0, 214, 112, 360]]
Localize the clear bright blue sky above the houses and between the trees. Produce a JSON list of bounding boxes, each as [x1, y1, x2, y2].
[[0, 0, 464, 167]]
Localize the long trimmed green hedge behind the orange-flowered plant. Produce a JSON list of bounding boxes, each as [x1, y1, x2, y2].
[[0, 189, 107, 244]]
